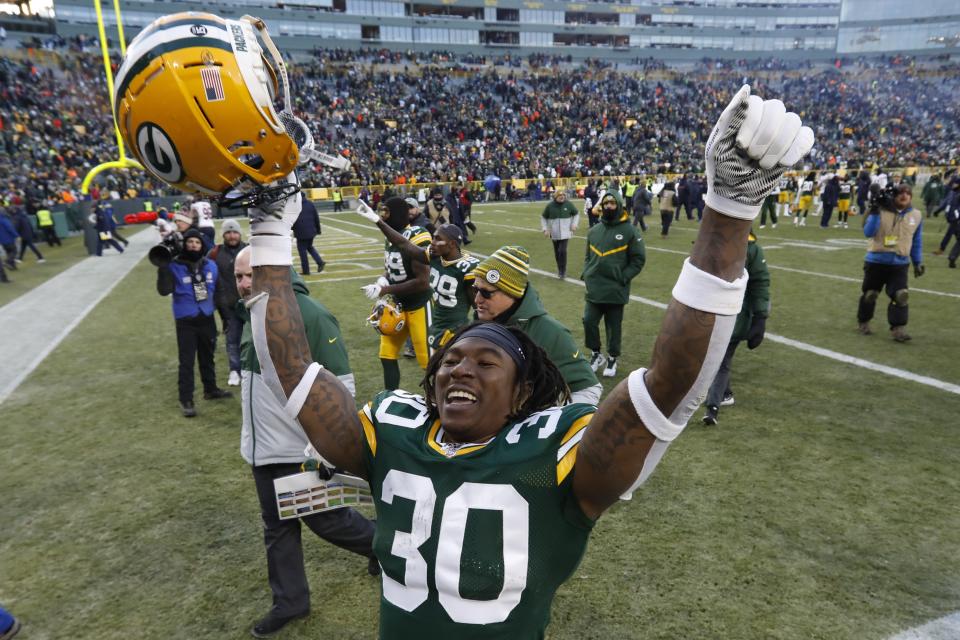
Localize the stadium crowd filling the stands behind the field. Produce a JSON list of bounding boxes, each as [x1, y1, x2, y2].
[[0, 47, 960, 208]]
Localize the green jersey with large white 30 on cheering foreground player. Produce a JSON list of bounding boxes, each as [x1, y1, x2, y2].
[[360, 391, 596, 640]]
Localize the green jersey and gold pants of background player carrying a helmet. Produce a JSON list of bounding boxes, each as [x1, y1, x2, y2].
[[380, 227, 431, 367]]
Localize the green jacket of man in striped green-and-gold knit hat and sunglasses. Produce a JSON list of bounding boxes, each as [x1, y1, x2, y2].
[[503, 283, 600, 391]]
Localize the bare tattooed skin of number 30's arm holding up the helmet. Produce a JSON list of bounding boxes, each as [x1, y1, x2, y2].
[[253, 266, 366, 477]]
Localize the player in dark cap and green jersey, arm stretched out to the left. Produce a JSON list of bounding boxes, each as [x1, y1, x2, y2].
[[368, 217, 480, 349]]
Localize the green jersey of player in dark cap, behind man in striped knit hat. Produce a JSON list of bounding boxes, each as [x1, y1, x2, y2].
[[427, 255, 480, 349]]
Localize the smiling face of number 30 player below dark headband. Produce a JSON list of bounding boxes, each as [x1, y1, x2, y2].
[[433, 338, 517, 442]]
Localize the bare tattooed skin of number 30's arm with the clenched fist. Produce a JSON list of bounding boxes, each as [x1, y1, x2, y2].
[[573, 207, 750, 518]]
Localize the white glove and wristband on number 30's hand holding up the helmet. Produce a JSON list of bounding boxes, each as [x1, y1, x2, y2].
[[247, 172, 303, 267]]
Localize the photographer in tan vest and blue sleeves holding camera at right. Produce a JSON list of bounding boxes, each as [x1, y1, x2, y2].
[[857, 183, 925, 342]]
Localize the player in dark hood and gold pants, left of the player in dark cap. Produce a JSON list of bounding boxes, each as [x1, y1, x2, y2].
[[363, 197, 432, 389]]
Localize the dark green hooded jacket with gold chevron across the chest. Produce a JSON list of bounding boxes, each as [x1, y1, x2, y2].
[[580, 207, 647, 304]]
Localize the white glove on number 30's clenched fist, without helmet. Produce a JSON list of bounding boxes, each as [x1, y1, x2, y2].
[[705, 85, 813, 220]]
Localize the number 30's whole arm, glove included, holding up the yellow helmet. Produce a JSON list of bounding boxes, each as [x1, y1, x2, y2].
[[247, 178, 366, 476]]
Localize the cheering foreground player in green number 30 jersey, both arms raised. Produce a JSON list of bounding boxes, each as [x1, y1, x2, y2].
[[242, 86, 813, 639]]
